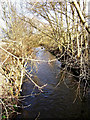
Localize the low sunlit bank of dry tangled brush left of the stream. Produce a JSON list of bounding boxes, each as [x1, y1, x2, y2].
[[0, 42, 26, 120]]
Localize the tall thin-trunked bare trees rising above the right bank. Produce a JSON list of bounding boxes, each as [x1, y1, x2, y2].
[[26, 0, 90, 95]]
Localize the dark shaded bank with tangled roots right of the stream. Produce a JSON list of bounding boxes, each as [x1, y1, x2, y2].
[[41, 44, 90, 95]]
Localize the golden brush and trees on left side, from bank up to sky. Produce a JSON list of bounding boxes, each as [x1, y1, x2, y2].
[[0, 2, 44, 119]]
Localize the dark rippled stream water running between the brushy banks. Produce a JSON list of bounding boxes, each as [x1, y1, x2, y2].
[[16, 48, 90, 120]]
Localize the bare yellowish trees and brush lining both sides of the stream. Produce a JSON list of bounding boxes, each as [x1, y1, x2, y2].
[[0, 0, 90, 119]]
